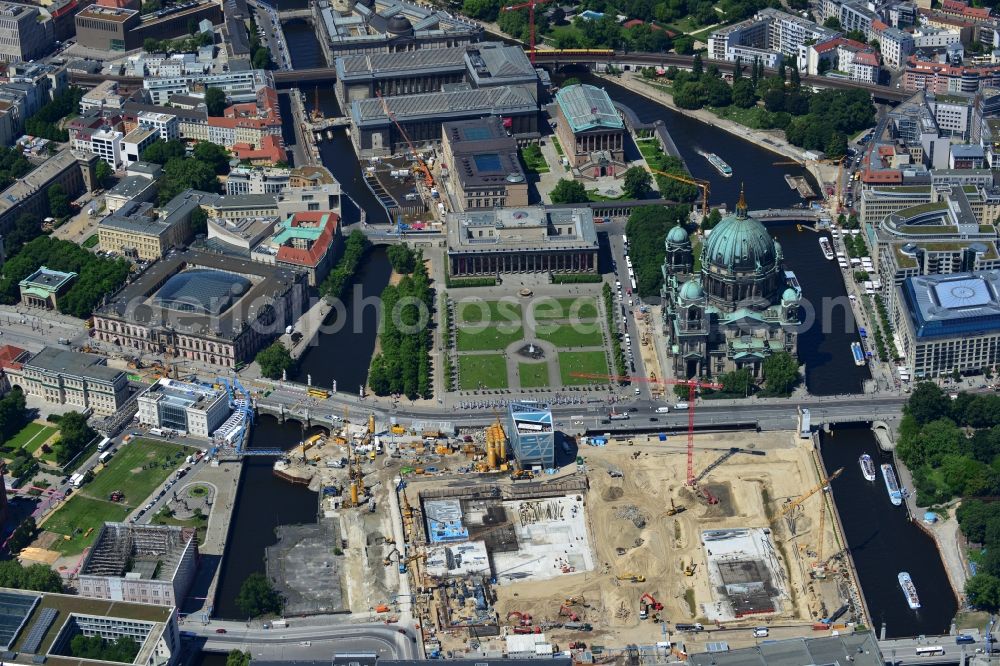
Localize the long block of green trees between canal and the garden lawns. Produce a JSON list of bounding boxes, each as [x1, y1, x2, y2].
[[368, 248, 434, 400]]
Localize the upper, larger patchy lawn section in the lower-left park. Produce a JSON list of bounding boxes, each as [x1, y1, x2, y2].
[[80, 439, 194, 508]]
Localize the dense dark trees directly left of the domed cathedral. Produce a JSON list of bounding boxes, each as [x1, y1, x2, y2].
[[625, 205, 690, 297]]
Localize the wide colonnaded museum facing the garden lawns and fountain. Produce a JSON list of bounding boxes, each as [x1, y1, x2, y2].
[[446, 206, 598, 277]]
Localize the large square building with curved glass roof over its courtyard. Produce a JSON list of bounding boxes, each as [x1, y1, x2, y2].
[[94, 250, 307, 368]]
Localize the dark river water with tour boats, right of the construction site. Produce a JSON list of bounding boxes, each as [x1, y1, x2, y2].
[[820, 424, 958, 636]]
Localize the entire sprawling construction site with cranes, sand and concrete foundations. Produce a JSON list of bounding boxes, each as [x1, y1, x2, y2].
[[269, 404, 864, 660]]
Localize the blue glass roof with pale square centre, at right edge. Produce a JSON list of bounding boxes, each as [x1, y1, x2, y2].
[[900, 271, 1000, 338]]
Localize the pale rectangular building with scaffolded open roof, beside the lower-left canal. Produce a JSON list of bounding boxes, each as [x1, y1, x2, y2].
[[79, 523, 198, 606]]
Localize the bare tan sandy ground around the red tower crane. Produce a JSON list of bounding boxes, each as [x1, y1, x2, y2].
[[488, 433, 837, 645]]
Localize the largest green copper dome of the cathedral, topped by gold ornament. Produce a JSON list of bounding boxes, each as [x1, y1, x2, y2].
[[701, 187, 781, 271]]
